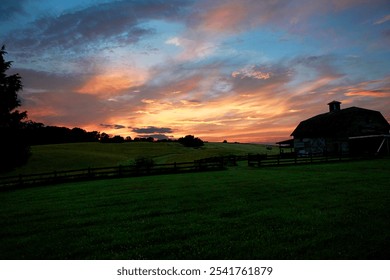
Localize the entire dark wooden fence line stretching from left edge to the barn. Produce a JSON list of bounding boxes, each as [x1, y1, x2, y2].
[[0, 153, 384, 191]]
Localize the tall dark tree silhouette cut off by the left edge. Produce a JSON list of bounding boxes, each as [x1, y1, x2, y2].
[[0, 46, 30, 171]]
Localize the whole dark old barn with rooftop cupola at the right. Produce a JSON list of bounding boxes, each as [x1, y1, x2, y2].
[[291, 101, 390, 155]]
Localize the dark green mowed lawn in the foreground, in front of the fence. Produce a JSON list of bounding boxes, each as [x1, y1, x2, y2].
[[0, 159, 390, 259]]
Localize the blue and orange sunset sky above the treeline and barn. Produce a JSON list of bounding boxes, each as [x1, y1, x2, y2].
[[0, 0, 390, 143]]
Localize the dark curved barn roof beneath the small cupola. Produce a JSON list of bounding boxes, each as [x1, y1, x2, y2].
[[291, 107, 390, 138]]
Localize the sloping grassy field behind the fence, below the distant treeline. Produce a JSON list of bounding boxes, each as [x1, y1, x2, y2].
[[1, 142, 279, 176]]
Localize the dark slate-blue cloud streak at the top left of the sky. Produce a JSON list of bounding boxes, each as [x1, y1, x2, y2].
[[8, 1, 193, 49]]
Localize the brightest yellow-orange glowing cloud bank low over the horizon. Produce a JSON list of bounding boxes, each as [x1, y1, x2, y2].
[[122, 85, 295, 142]]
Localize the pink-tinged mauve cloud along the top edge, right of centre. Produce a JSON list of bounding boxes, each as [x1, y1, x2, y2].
[[186, 0, 387, 37]]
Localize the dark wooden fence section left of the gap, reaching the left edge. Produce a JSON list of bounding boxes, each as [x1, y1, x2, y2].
[[0, 158, 225, 190]]
